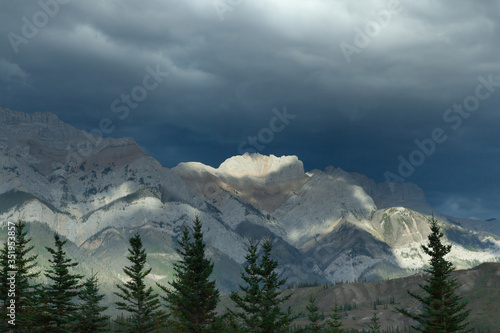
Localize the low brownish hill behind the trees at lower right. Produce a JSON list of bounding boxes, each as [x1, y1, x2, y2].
[[231, 263, 500, 332]]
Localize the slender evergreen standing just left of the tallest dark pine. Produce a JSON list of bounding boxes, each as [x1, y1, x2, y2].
[[114, 233, 166, 333]]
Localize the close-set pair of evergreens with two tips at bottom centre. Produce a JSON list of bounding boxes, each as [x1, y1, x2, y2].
[[230, 238, 298, 333]]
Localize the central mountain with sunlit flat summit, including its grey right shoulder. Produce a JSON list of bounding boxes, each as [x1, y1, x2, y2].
[[173, 154, 376, 247]]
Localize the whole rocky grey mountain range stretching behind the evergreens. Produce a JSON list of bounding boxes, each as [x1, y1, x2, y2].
[[0, 109, 500, 300]]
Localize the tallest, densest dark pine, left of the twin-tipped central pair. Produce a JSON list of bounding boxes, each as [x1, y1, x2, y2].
[[158, 217, 220, 332]]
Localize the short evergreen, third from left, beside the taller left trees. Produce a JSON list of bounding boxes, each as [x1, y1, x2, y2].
[[77, 274, 110, 333]]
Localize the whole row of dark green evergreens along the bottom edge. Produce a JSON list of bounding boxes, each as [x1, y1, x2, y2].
[[0, 217, 472, 333]]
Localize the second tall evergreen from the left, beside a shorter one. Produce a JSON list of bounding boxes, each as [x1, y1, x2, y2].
[[41, 234, 83, 333]]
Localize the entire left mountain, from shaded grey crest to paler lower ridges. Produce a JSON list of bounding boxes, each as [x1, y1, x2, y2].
[[0, 109, 205, 244]]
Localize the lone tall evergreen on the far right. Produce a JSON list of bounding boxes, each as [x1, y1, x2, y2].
[[397, 216, 471, 333]]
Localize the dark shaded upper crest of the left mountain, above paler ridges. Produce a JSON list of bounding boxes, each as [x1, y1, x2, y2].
[[0, 108, 149, 175]]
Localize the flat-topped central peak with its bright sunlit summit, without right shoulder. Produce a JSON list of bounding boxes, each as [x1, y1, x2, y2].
[[173, 154, 310, 222]]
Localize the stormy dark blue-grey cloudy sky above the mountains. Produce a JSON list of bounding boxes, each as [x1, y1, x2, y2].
[[0, 0, 500, 219]]
